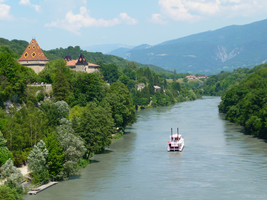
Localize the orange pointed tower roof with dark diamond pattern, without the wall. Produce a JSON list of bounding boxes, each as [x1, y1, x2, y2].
[[18, 39, 49, 61]]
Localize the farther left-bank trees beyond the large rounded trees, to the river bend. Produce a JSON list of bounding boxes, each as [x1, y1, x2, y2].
[[97, 61, 202, 108]]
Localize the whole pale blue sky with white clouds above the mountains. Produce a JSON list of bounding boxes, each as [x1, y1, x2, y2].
[[0, 0, 267, 50]]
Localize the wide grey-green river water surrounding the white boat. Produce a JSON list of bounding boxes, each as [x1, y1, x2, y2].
[[25, 97, 267, 200]]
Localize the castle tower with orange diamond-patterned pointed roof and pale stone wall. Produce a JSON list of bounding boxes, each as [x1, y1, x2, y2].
[[18, 39, 49, 74]]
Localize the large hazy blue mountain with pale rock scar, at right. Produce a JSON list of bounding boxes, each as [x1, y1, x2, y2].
[[110, 20, 267, 74]]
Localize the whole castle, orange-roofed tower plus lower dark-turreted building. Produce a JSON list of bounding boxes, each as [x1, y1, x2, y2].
[[18, 39, 100, 74]]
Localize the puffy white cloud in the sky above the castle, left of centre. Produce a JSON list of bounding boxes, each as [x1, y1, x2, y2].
[[45, 6, 138, 34]]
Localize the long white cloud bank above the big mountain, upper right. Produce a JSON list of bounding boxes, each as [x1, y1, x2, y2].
[[150, 0, 267, 23]]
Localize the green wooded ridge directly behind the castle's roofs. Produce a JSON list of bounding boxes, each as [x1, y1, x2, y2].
[[0, 38, 171, 72]]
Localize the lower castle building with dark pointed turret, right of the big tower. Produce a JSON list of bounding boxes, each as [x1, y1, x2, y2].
[[64, 53, 100, 73]]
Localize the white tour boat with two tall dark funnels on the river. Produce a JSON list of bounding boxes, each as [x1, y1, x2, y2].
[[168, 128, 184, 152]]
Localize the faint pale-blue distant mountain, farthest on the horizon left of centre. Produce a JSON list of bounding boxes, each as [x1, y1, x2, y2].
[[82, 44, 134, 54]]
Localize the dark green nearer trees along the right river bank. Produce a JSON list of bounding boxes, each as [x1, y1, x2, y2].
[[219, 65, 267, 138]]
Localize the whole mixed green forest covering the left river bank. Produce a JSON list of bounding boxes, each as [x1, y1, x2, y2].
[[0, 47, 202, 199]]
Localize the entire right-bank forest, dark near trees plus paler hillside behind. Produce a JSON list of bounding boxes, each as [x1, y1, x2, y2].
[[203, 64, 267, 138]]
